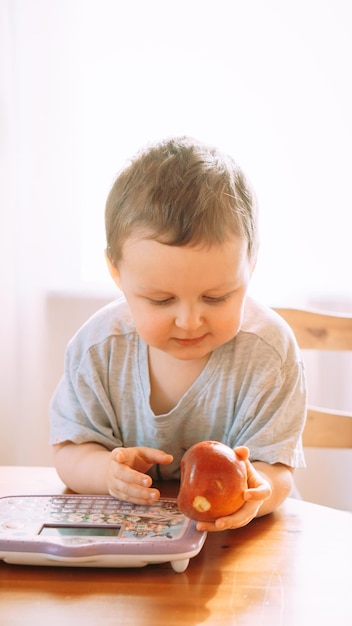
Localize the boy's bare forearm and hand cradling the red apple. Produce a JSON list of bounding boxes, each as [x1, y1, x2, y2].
[[197, 461, 293, 531]]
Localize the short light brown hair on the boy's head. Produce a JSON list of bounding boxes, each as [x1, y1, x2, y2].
[[105, 137, 258, 265]]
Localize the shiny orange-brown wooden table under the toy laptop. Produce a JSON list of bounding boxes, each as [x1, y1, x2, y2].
[[0, 467, 352, 626]]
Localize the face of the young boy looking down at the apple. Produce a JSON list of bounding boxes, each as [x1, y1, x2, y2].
[[110, 236, 254, 360]]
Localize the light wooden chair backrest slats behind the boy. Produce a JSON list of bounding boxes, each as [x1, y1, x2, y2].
[[274, 308, 352, 448]]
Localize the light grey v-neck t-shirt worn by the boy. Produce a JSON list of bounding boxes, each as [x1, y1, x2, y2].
[[50, 298, 306, 479]]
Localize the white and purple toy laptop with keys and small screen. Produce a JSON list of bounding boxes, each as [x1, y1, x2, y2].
[[0, 495, 206, 572]]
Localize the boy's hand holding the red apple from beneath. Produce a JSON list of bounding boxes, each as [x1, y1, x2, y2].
[[197, 459, 272, 532]]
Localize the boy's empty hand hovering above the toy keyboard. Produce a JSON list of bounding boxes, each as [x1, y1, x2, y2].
[[107, 446, 173, 504]]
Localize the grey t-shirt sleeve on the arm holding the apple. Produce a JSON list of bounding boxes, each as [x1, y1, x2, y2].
[[224, 330, 306, 468]]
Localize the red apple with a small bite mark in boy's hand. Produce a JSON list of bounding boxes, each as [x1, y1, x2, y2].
[[177, 441, 249, 522]]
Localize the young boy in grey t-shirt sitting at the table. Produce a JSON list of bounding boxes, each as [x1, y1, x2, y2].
[[51, 137, 306, 531]]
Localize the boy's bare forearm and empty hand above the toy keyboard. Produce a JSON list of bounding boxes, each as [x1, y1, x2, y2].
[[53, 441, 172, 504]]
